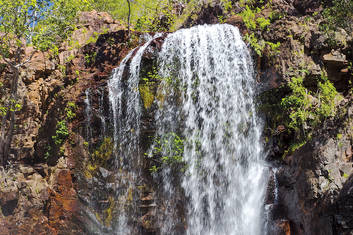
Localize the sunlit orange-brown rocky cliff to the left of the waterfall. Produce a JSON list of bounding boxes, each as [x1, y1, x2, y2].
[[0, 12, 128, 234]]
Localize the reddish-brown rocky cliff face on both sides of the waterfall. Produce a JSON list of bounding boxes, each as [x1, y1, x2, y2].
[[0, 0, 353, 235]]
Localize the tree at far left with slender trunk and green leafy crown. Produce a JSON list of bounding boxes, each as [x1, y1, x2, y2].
[[0, 0, 90, 165]]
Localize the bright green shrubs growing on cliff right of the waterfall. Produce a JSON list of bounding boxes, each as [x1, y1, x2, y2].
[[259, 69, 342, 157]]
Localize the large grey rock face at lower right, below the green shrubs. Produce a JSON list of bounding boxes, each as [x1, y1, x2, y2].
[[278, 102, 353, 235]]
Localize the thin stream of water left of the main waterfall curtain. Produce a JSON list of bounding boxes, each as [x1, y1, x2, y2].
[[108, 34, 160, 235]]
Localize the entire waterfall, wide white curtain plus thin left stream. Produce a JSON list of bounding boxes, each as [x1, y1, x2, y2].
[[108, 25, 269, 235]]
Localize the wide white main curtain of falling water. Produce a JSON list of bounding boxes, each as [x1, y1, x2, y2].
[[157, 25, 267, 235]]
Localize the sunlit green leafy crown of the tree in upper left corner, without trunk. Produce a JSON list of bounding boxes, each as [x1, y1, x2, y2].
[[0, 0, 92, 52]]
